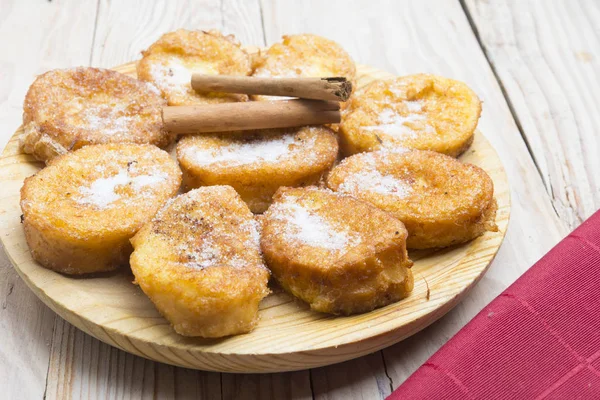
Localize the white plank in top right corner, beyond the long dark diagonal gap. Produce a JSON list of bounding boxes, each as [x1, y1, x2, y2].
[[466, 0, 600, 228]]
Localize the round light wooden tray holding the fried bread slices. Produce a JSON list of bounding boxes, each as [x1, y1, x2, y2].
[[0, 63, 510, 372]]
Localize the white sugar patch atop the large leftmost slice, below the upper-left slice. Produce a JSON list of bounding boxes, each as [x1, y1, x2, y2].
[[75, 169, 167, 209]]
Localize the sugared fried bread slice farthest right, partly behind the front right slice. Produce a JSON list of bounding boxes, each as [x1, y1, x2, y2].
[[327, 150, 497, 249]]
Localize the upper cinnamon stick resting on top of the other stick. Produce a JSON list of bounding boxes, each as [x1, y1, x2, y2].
[[192, 74, 352, 101]]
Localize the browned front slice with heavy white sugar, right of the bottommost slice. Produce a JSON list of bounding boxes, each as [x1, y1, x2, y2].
[[261, 188, 413, 314]]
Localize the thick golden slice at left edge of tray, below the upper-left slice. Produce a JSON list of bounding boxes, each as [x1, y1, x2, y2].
[[21, 144, 181, 275]]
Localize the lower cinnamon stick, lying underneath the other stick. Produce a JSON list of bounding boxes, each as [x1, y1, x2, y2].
[[162, 100, 341, 134]]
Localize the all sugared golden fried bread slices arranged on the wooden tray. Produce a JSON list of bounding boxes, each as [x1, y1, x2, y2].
[[21, 30, 497, 337]]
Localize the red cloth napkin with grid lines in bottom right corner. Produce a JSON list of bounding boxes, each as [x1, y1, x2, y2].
[[388, 211, 600, 400]]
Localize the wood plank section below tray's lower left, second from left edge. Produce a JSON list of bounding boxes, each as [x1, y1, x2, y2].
[[46, 318, 221, 399]]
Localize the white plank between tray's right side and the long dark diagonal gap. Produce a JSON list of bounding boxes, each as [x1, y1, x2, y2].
[[263, 0, 566, 398]]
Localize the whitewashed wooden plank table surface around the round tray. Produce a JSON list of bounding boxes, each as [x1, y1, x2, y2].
[[0, 0, 600, 399]]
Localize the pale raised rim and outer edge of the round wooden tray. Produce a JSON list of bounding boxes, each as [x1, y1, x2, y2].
[[0, 61, 511, 373]]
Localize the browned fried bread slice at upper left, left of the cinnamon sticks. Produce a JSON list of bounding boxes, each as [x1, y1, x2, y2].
[[21, 67, 174, 161]]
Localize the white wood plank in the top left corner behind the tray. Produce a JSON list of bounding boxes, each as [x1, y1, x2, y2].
[[0, 0, 97, 148]]
